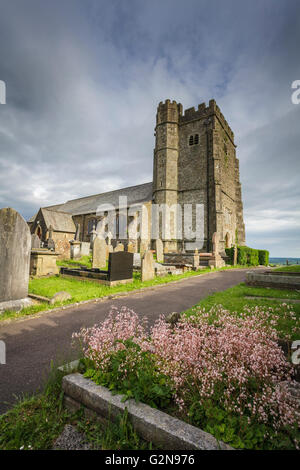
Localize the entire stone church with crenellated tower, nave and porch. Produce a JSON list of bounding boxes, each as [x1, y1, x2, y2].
[[28, 100, 245, 257]]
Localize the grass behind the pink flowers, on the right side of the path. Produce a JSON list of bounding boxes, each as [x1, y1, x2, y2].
[[183, 283, 300, 340]]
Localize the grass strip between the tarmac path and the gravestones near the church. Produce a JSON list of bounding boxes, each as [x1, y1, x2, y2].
[[0, 266, 245, 322]]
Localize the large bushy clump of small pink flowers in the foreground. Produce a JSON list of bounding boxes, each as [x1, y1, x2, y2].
[[73, 306, 300, 447]]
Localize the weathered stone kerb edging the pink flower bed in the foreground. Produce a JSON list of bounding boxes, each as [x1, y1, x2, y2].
[[62, 373, 233, 450]]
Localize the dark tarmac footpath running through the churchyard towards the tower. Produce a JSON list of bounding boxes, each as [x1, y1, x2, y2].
[[0, 269, 252, 413]]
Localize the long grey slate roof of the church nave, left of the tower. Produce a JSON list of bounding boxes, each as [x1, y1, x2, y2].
[[45, 182, 152, 215]]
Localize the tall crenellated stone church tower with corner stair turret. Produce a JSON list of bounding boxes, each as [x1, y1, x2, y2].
[[153, 100, 245, 252]]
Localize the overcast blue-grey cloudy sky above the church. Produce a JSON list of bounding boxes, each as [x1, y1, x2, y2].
[[0, 0, 300, 257]]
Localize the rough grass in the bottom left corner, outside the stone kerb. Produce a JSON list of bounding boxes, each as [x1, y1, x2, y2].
[[0, 366, 152, 450]]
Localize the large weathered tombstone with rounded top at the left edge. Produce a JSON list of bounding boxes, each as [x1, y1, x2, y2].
[[0, 208, 31, 310]]
